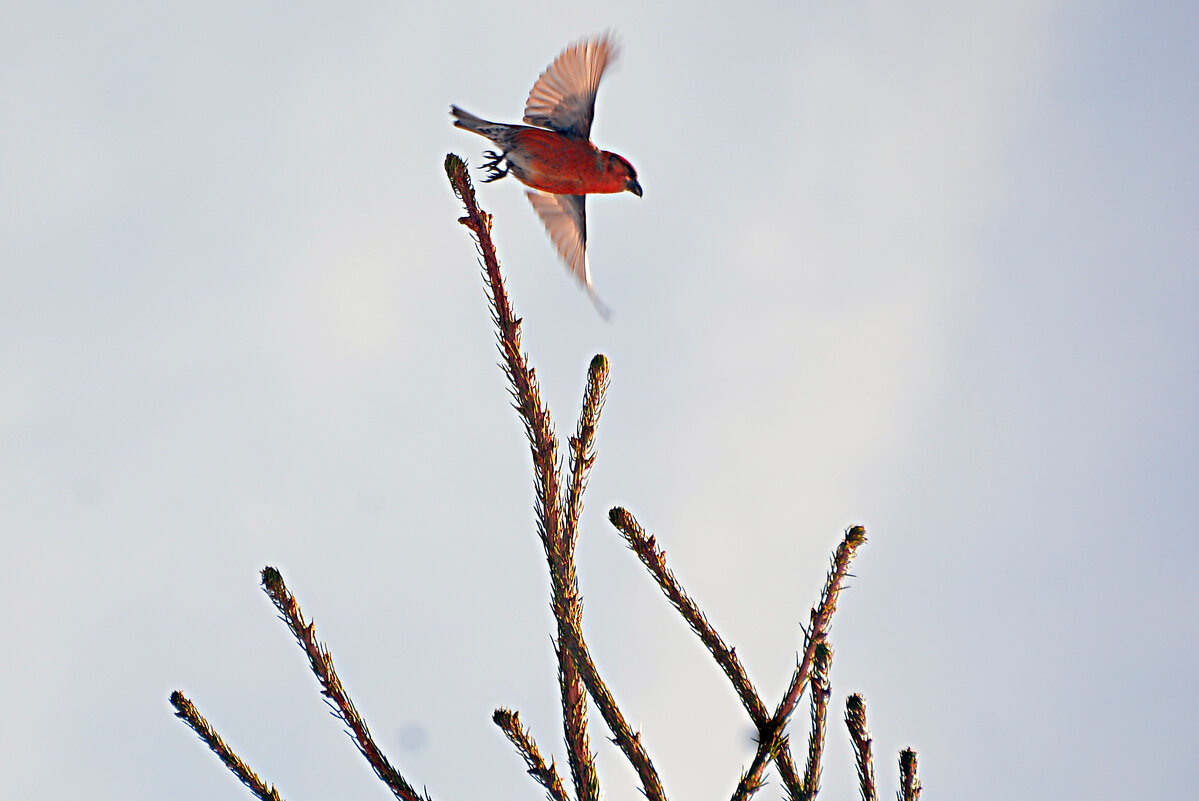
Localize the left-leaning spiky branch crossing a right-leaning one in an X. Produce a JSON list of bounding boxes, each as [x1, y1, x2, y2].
[[608, 506, 801, 794]]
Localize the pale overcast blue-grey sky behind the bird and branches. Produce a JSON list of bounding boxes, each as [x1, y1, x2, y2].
[[0, 0, 1199, 801]]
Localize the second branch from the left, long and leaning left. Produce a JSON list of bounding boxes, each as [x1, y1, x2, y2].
[[263, 567, 429, 801]]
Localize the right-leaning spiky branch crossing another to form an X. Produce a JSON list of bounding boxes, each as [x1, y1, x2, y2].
[[733, 525, 866, 801]]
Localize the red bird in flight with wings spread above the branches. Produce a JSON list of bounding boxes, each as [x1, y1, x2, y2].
[[450, 35, 641, 317]]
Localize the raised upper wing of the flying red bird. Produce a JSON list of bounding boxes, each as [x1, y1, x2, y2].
[[524, 34, 617, 139]]
